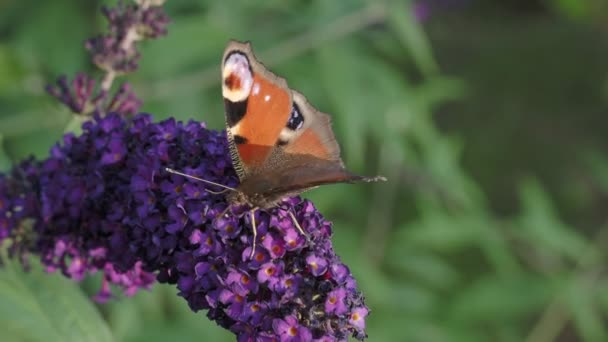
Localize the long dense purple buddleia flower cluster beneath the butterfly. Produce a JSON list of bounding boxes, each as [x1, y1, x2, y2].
[[0, 0, 369, 341]]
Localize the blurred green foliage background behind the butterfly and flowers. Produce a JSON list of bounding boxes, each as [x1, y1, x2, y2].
[[0, 0, 608, 342]]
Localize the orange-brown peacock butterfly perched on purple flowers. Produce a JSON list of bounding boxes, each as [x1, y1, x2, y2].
[[167, 41, 386, 255]]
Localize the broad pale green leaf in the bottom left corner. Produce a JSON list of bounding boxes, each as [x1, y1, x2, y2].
[[0, 261, 114, 342]]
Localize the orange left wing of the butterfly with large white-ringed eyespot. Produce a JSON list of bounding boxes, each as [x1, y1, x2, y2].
[[222, 41, 292, 181]]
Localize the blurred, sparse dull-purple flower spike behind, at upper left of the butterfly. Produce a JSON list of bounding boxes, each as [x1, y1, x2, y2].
[[47, 0, 169, 117]]
